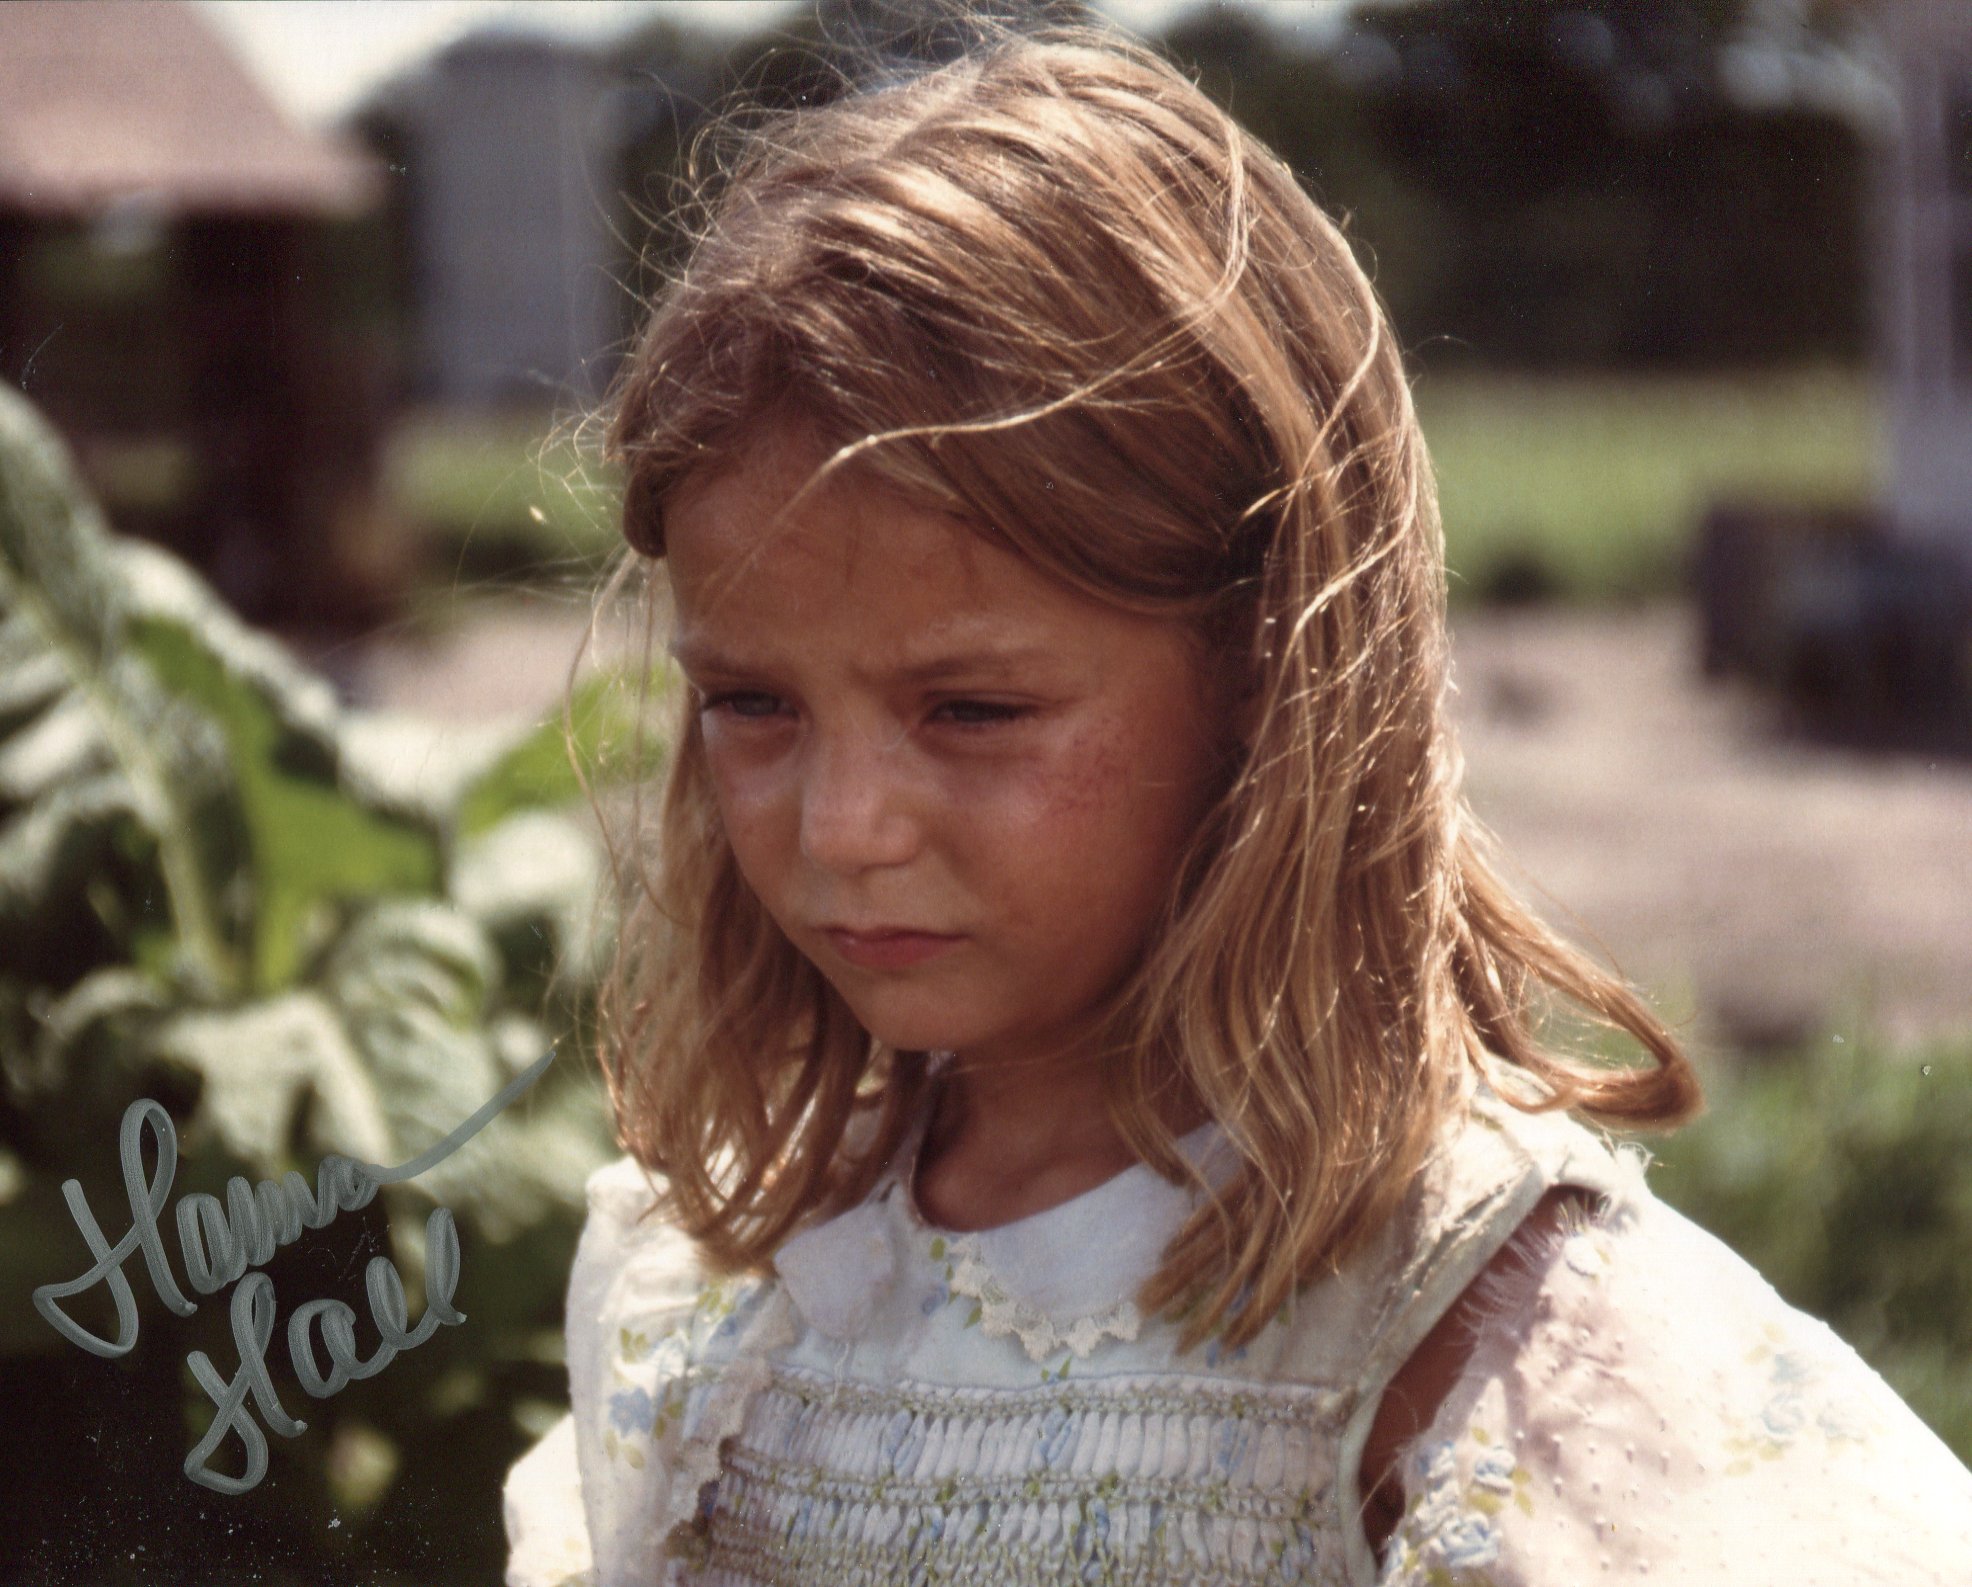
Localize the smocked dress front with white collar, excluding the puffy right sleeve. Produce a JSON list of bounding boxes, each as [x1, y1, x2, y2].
[[504, 1098, 1627, 1587]]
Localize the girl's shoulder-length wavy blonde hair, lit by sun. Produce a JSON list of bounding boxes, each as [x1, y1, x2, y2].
[[579, 9, 1698, 1345]]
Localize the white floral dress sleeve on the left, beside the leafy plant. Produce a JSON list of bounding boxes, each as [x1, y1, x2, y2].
[[505, 1157, 700, 1587]]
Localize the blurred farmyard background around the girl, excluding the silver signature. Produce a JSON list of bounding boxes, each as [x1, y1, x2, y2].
[[0, 0, 1972, 1583]]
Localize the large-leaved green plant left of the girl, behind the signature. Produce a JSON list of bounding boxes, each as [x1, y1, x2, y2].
[[0, 390, 655, 1581]]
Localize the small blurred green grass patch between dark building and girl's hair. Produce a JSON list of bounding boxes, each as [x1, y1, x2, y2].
[[385, 414, 621, 587]]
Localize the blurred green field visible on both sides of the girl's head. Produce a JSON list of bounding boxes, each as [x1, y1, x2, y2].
[[387, 371, 1881, 603]]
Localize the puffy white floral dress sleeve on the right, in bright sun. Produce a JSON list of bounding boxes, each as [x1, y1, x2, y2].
[[1380, 1193, 1972, 1587]]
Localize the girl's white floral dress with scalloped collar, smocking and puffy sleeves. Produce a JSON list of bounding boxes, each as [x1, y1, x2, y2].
[[507, 1094, 1972, 1587]]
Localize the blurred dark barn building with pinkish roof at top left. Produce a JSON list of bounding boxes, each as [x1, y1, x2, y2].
[[0, 0, 392, 627]]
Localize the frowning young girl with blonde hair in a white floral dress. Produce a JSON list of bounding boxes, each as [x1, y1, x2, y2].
[[507, 15, 1972, 1587]]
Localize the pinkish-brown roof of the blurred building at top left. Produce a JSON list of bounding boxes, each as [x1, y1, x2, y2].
[[0, 0, 381, 215]]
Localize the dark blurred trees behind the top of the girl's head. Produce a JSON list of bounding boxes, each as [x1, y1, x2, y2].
[[607, 0, 1885, 371]]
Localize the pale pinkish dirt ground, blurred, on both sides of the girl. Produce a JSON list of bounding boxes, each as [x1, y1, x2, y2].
[[337, 597, 1972, 1047]]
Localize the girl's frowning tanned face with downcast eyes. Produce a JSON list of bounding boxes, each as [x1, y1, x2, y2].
[[665, 423, 1227, 1067]]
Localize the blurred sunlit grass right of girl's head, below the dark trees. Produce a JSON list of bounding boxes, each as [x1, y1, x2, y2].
[[1416, 371, 1883, 603]]
